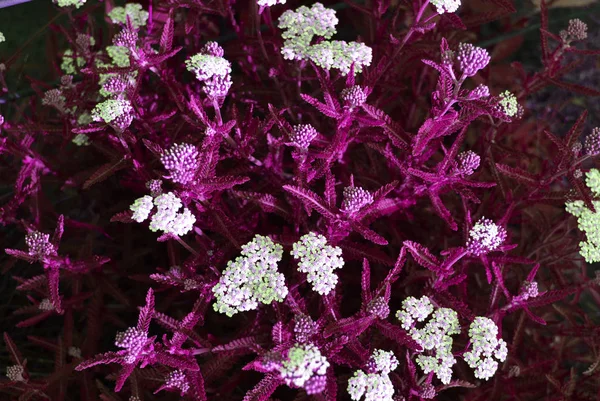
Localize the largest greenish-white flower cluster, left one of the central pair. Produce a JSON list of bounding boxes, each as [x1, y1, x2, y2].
[[212, 235, 288, 317]]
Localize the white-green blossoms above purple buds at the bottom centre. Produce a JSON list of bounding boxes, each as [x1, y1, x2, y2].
[[279, 344, 329, 387]]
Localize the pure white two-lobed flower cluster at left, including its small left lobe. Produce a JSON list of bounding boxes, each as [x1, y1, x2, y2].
[[129, 192, 196, 236]]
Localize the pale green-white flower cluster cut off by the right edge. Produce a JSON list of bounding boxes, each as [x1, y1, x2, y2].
[[565, 169, 600, 263]]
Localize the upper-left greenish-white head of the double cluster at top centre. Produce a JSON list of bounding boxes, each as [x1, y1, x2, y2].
[[279, 3, 338, 60]]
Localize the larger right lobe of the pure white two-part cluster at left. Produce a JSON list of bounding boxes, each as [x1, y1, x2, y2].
[[150, 192, 196, 236]]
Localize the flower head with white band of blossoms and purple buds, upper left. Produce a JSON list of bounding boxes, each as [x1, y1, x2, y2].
[[185, 42, 232, 99]]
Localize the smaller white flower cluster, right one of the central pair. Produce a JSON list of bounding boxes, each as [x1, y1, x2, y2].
[[291, 232, 344, 295]]
